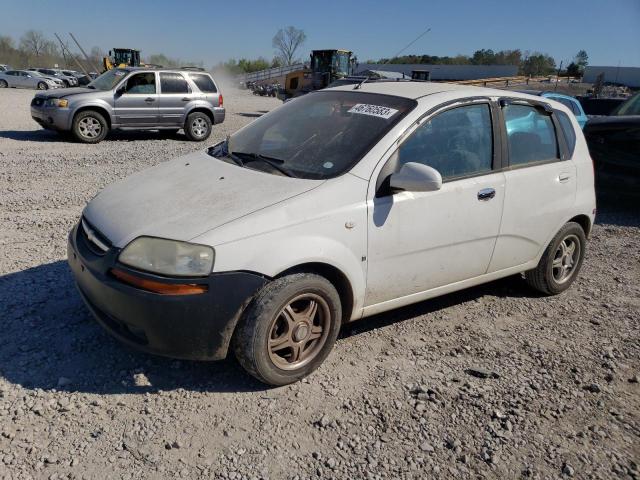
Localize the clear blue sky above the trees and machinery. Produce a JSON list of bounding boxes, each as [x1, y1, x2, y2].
[[0, 0, 640, 67]]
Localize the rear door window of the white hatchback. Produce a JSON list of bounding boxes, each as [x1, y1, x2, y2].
[[502, 104, 560, 165]]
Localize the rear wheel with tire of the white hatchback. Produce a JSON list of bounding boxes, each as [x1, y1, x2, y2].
[[525, 222, 587, 295]]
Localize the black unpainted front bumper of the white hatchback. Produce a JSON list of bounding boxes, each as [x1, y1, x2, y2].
[[67, 221, 266, 360]]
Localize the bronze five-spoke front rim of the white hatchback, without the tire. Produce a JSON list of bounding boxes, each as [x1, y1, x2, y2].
[[268, 293, 331, 370]]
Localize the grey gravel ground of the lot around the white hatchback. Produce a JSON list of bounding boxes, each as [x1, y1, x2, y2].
[[0, 86, 640, 479]]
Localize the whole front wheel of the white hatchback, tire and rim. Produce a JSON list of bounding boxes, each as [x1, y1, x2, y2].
[[233, 273, 342, 386]]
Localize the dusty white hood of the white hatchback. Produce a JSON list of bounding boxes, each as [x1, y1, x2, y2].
[[83, 152, 323, 248]]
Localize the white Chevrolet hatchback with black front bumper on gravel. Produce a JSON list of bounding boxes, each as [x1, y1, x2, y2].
[[68, 82, 595, 385]]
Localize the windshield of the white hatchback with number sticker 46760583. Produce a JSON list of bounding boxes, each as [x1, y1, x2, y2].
[[209, 90, 417, 179]]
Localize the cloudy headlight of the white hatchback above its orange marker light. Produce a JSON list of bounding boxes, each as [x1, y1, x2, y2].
[[118, 237, 215, 277]]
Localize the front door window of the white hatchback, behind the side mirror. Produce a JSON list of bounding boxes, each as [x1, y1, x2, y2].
[[396, 103, 493, 181]]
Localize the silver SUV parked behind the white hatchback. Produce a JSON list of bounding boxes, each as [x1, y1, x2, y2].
[[31, 68, 225, 143]]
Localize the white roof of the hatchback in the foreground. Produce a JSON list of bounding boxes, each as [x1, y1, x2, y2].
[[327, 81, 539, 101]]
